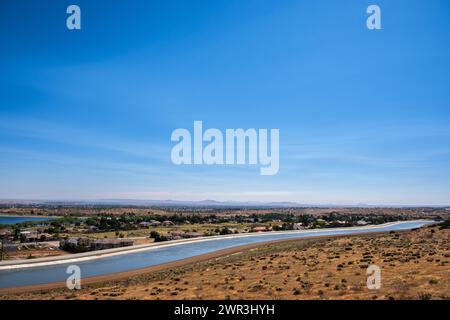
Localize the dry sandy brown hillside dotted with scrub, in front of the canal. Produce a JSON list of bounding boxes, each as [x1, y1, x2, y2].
[[0, 227, 450, 299]]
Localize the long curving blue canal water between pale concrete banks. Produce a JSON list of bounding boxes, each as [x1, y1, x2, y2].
[[0, 220, 433, 288]]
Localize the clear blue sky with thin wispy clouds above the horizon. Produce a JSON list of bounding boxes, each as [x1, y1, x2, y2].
[[0, 0, 450, 205]]
